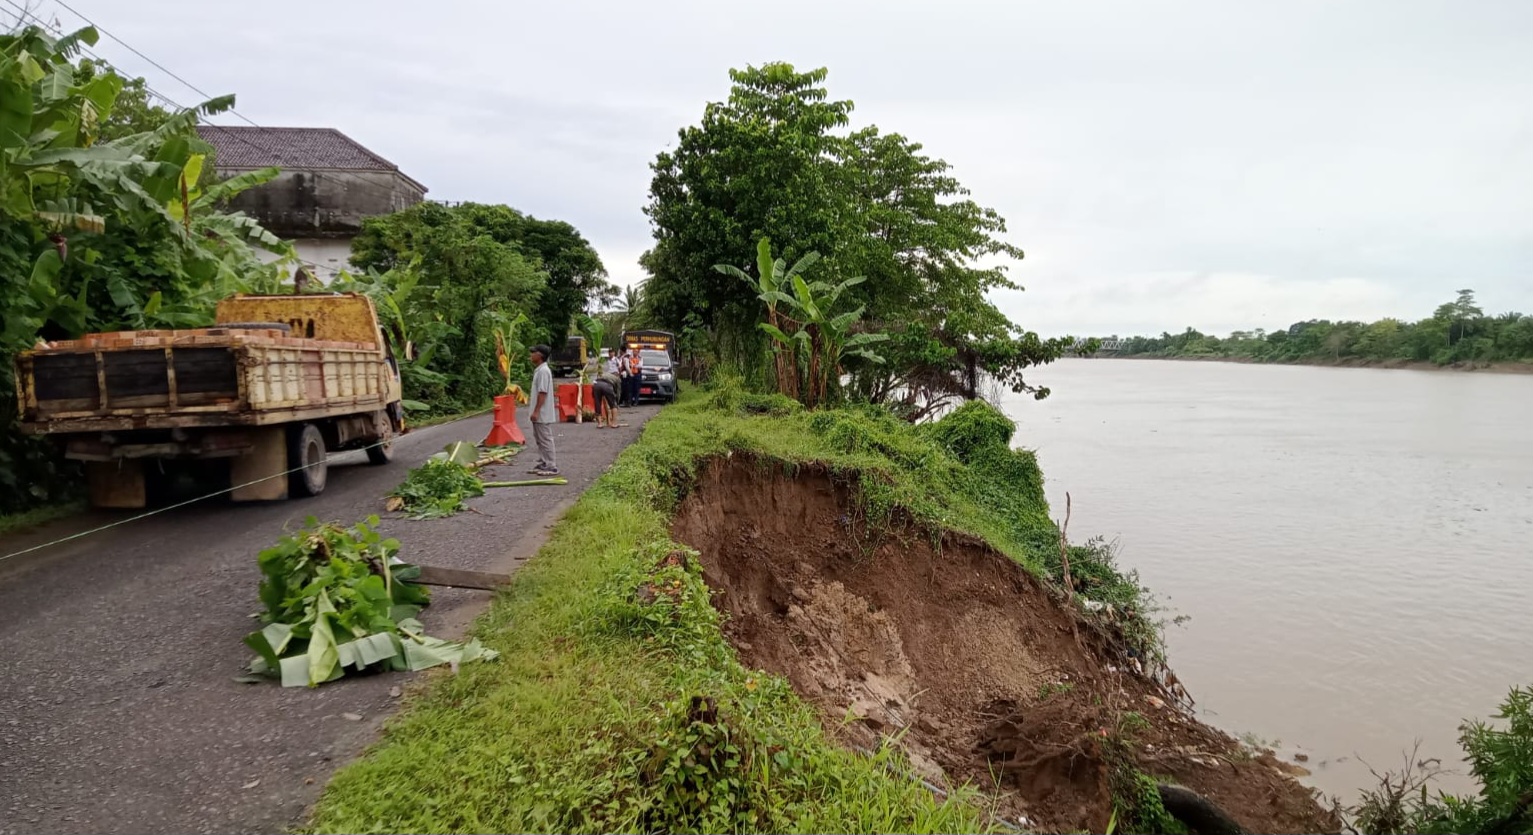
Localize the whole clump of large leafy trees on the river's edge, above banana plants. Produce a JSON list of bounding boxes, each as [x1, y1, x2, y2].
[[641, 63, 1072, 418]]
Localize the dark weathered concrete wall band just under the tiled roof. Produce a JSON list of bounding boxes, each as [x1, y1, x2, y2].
[[219, 170, 426, 237]]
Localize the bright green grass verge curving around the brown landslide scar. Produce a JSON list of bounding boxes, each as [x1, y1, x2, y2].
[[311, 389, 1137, 832]]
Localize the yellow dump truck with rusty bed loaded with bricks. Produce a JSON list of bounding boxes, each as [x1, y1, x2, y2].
[[17, 293, 405, 507]]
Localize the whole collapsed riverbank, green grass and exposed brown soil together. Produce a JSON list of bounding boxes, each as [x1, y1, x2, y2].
[[311, 389, 1337, 832]]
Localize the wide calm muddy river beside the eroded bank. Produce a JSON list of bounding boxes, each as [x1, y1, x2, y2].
[[1007, 360, 1533, 800]]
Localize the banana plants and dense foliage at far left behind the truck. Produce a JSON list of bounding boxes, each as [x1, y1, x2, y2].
[[0, 26, 288, 513]]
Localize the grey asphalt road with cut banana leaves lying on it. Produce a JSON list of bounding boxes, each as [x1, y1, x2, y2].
[[0, 406, 658, 835]]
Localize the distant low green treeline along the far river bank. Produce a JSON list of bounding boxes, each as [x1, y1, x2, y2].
[[1116, 290, 1533, 365]]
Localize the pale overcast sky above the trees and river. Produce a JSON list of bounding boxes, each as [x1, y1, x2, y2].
[[23, 0, 1533, 336]]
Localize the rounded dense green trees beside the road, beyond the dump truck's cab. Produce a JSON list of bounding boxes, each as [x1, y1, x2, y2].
[[336, 204, 616, 414]]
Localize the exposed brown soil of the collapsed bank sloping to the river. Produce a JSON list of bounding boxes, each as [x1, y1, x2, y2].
[[671, 455, 1338, 832]]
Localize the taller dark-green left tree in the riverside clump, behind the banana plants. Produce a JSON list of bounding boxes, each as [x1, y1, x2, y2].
[[641, 63, 852, 363]]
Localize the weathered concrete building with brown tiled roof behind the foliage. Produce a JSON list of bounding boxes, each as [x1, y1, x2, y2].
[[198, 124, 426, 282]]
